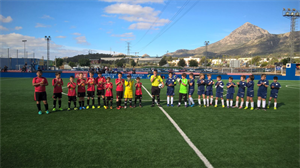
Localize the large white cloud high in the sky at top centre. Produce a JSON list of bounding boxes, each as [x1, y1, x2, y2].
[[105, 3, 170, 30]]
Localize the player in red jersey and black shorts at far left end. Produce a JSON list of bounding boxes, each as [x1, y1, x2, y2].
[[32, 70, 50, 115]]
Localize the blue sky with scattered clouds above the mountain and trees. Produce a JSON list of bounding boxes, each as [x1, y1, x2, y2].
[[0, 0, 300, 59]]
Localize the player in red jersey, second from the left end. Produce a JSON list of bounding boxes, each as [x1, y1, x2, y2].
[[52, 72, 64, 111]]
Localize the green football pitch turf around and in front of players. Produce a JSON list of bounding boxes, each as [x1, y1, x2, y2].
[[0, 78, 300, 168]]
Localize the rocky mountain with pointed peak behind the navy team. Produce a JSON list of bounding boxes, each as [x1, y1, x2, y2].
[[168, 22, 300, 58]]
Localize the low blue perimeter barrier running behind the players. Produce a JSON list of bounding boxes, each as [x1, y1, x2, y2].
[[0, 72, 300, 80]]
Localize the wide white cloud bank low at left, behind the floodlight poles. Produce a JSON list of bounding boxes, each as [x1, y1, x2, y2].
[[0, 33, 110, 60]]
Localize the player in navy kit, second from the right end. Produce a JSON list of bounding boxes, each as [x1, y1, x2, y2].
[[256, 74, 269, 111]]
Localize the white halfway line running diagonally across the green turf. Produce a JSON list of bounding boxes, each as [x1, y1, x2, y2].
[[142, 85, 213, 168]]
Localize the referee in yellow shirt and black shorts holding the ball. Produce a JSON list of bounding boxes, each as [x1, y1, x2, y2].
[[150, 69, 165, 107]]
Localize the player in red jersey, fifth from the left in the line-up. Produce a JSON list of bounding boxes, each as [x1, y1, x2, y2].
[[86, 71, 97, 109]]
